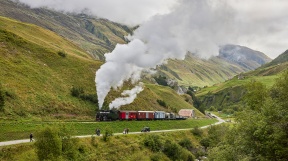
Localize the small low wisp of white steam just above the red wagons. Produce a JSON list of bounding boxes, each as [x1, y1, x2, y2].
[[109, 83, 143, 109]]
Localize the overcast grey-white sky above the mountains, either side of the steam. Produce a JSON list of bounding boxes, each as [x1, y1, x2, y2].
[[19, 0, 288, 58]]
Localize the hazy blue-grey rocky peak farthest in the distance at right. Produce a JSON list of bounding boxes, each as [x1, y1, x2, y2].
[[219, 45, 271, 70]]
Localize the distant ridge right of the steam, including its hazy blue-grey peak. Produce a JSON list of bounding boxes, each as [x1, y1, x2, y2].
[[159, 45, 271, 87]]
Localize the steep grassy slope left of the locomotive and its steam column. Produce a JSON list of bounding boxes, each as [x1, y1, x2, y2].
[[0, 19, 100, 119]]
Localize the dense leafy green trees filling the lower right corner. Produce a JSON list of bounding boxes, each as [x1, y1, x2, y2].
[[209, 71, 288, 160]]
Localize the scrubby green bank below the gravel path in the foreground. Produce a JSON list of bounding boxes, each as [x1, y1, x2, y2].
[[0, 128, 214, 161]]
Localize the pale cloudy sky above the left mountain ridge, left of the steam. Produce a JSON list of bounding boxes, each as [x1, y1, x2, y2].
[[19, 0, 177, 25]]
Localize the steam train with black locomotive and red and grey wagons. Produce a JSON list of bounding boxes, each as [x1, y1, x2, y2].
[[96, 110, 186, 121]]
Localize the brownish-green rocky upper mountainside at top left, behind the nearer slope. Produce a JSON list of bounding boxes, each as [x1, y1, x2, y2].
[[0, 0, 132, 60]]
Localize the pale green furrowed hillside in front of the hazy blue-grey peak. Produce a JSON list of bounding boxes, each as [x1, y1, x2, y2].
[[159, 54, 247, 87]]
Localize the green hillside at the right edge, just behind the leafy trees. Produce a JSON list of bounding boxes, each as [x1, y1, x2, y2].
[[197, 59, 288, 114]]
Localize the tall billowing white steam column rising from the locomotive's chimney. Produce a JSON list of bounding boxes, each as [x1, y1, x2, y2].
[[95, 0, 236, 109]]
